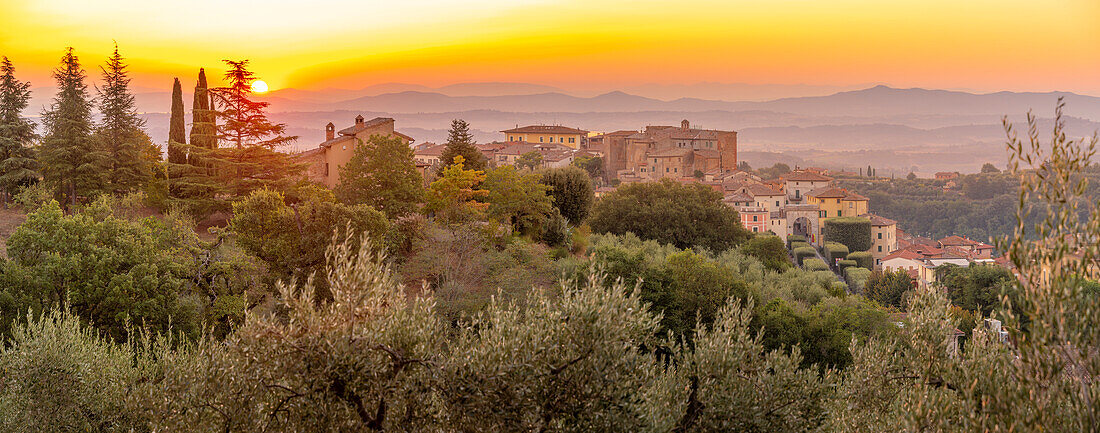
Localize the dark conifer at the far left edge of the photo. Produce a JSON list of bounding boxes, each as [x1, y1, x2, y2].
[[0, 57, 39, 203]]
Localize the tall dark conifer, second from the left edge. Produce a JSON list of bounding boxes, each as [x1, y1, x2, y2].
[[41, 47, 103, 206]]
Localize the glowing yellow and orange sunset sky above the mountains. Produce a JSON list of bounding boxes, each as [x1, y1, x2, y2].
[[0, 0, 1100, 96]]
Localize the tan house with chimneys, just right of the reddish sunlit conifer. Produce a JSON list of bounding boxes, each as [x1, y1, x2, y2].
[[298, 115, 413, 188]]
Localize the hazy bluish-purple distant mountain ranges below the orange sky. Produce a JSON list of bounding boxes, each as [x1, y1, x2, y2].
[[19, 82, 1100, 175]]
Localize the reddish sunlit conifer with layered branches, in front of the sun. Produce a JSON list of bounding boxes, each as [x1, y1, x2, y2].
[[210, 60, 304, 197]]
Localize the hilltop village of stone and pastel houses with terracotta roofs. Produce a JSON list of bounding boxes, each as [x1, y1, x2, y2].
[[298, 115, 1009, 287]]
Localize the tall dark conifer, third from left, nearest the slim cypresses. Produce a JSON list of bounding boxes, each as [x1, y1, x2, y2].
[[95, 46, 154, 192]]
